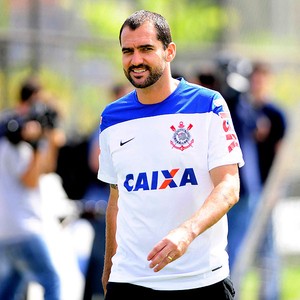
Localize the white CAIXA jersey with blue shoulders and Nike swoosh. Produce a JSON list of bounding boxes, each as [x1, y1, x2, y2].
[[98, 79, 243, 290]]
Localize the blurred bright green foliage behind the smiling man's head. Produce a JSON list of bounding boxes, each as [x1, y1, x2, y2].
[[80, 0, 228, 47]]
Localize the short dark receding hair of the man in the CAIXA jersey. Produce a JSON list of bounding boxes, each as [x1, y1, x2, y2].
[[119, 10, 172, 49]]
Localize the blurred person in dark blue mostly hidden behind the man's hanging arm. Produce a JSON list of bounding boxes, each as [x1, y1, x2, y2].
[[82, 83, 132, 300]]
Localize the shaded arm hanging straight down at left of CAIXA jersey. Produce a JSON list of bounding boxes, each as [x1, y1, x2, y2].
[[102, 184, 119, 293]]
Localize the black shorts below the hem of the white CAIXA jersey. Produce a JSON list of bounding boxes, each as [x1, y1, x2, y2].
[[105, 278, 235, 300]]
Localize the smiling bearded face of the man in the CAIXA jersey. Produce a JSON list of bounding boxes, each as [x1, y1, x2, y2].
[[121, 22, 167, 88]]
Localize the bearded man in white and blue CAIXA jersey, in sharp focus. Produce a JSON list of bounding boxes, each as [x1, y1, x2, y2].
[[98, 10, 243, 300]]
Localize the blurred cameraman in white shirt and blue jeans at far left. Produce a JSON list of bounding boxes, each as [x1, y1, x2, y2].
[[0, 78, 65, 300]]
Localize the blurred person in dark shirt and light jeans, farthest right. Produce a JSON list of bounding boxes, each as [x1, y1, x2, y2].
[[250, 62, 287, 300]]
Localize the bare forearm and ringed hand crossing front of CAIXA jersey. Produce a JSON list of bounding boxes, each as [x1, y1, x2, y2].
[[147, 164, 240, 272]]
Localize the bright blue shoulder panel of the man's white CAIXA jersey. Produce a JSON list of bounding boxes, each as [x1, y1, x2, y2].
[[100, 78, 222, 131]]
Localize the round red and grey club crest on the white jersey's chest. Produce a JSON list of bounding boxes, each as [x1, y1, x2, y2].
[[170, 121, 194, 151]]
